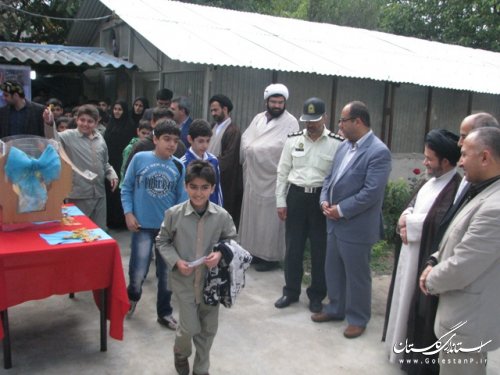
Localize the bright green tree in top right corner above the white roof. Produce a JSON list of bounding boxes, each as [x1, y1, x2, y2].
[[379, 0, 500, 51]]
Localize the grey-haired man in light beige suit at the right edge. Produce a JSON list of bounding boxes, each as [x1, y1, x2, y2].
[[419, 127, 500, 375]]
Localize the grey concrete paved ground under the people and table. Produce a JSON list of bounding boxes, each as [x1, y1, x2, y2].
[[0, 228, 500, 375]]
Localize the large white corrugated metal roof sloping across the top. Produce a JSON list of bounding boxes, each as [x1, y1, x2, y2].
[[100, 0, 500, 94]]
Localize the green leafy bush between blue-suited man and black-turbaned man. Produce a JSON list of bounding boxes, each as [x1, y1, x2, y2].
[[382, 179, 412, 244]]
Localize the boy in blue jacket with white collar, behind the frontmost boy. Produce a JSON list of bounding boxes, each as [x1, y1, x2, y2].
[[181, 119, 223, 206]]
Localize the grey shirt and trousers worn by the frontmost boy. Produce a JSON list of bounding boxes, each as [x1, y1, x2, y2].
[[156, 201, 237, 374]]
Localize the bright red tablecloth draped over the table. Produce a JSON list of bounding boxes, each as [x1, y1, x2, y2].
[[0, 216, 129, 340]]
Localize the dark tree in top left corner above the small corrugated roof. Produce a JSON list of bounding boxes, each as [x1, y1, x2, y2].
[[0, 0, 81, 44]]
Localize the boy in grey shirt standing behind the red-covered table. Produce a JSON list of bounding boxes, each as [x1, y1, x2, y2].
[[56, 105, 118, 229]]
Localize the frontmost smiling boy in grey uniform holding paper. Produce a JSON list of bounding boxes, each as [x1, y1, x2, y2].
[[157, 160, 237, 375]]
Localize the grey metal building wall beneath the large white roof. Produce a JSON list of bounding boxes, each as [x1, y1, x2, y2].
[[100, 23, 500, 154]]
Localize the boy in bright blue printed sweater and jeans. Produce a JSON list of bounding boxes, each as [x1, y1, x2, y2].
[[121, 120, 187, 330]]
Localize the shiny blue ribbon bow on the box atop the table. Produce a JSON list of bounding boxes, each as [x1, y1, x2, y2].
[[5, 144, 61, 212]]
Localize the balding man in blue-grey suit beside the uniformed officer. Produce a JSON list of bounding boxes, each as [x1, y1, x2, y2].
[[311, 101, 391, 338]]
